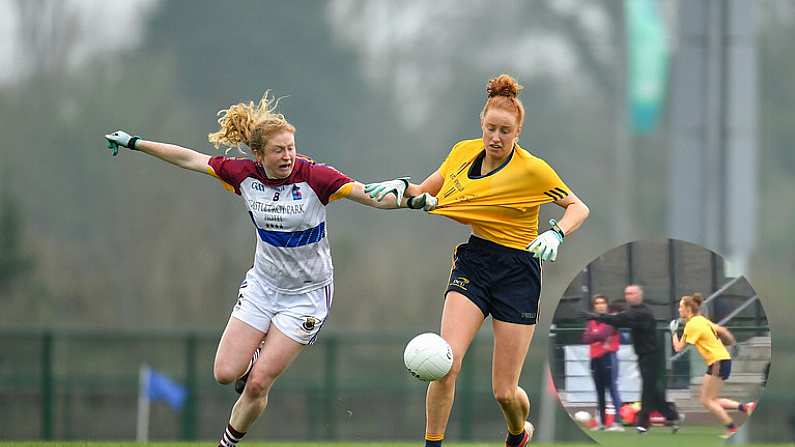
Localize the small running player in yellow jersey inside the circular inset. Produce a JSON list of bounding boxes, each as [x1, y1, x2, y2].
[[670, 293, 756, 438]]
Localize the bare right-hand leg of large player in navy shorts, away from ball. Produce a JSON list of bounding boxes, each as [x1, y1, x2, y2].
[[491, 320, 535, 433]]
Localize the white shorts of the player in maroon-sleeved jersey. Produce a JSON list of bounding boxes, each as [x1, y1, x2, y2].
[[232, 277, 334, 345]]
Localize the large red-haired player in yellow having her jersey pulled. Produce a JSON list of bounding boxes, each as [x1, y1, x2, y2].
[[365, 75, 589, 447]]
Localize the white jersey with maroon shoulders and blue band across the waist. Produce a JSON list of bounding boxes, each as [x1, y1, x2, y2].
[[209, 156, 353, 294]]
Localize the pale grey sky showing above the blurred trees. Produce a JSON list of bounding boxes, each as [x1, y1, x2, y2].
[[0, 0, 620, 128]]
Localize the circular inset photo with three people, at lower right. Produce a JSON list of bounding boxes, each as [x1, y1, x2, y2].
[[549, 239, 771, 445]]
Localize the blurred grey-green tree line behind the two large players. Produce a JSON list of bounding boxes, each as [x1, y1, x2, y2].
[[0, 0, 795, 331]]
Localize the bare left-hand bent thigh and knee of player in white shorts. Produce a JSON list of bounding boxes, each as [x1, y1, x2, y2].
[[213, 317, 265, 384]]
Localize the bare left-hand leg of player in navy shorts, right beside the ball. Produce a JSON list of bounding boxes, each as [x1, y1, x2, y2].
[[425, 291, 484, 440]]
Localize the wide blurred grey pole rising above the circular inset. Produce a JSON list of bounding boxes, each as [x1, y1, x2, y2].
[[668, 0, 758, 277]]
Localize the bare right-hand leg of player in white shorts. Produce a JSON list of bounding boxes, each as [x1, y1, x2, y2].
[[229, 325, 304, 433]]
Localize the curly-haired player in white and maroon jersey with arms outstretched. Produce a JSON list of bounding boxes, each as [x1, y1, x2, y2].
[[105, 93, 436, 447]]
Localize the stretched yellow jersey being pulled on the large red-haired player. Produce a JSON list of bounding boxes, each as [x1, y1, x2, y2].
[[431, 138, 569, 250]]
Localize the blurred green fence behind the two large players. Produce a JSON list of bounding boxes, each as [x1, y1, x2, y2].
[[0, 331, 543, 440]]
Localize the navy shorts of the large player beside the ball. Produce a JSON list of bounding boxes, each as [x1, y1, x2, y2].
[[447, 236, 541, 324]]
